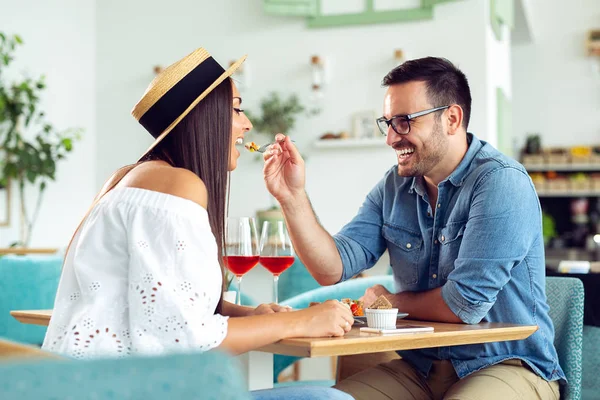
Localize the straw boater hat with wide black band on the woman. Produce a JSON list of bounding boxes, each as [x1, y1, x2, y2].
[[131, 47, 247, 159]]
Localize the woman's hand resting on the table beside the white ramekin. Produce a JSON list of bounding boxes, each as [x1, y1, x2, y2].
[[297, 300, 354, 337]]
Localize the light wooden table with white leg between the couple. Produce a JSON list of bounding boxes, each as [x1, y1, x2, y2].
[[10, 310, 538, 390]]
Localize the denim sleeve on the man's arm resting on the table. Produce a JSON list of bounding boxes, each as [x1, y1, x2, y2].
[[442, 167, 541, 324]]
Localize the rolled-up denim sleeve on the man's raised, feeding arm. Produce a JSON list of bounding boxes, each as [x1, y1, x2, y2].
[[333, 179, 385, 282]]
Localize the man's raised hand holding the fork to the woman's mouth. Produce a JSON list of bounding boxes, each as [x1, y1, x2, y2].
[[263, 133, 305, 204]]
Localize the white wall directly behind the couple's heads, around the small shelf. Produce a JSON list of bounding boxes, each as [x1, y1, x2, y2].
[[97, 0, 486, 238]]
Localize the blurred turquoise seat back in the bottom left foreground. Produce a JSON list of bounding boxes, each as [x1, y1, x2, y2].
[[0, 351, 251, 400]]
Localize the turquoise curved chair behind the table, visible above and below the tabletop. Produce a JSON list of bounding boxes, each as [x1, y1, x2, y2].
[[273, 275, 395, 384]]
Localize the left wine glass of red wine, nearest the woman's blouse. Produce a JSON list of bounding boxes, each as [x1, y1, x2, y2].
[[223, 217, 259, 305]]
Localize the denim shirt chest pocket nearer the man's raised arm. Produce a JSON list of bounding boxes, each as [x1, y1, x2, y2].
[[382, 223, 423, 285]]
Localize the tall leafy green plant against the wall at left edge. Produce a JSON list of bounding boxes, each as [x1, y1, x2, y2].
[[0, 32, 81, 247]]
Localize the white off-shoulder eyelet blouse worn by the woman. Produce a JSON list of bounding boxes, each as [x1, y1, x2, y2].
[[43, 188, 227, 359]]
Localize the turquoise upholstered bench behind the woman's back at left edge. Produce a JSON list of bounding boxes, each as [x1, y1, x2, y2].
[[0, 255, 63, 344]]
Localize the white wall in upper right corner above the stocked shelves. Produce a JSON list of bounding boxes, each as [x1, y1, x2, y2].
[[512, 0, 600, 146]]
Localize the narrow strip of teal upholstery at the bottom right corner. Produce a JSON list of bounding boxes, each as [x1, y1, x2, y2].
[[582, 325, 600, 400]]
